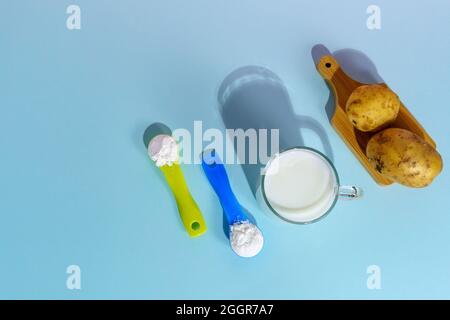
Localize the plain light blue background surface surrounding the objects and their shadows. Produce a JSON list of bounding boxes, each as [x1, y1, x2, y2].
[[0, 0, 450, 299]]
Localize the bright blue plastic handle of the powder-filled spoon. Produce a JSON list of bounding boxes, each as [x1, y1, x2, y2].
[[202, 150, 248, 225]]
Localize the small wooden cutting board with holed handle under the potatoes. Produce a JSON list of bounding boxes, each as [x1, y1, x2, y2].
[[316, 55, 436, 185]]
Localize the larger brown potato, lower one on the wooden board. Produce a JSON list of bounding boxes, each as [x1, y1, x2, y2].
[[366, 128, 443, 188]]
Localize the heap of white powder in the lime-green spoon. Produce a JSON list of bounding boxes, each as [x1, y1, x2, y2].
[[148, 134, 178, 167]]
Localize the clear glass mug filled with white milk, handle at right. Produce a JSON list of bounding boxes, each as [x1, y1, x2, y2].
[[256, 147, 362, 224]]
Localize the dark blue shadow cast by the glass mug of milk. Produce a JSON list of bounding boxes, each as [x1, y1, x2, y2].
[[218, 66, 333, 194]]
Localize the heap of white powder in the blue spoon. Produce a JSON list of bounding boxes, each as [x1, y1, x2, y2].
[[230, 221, 264, 258]]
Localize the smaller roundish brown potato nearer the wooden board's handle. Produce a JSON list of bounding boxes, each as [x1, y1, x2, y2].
[[345, 84, 400, 132]]
